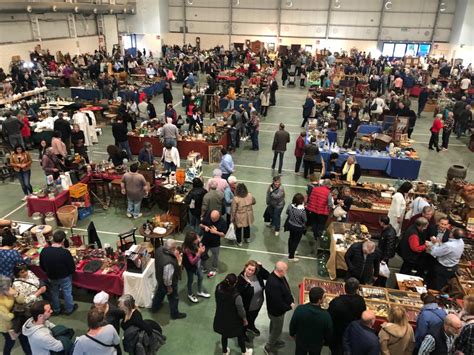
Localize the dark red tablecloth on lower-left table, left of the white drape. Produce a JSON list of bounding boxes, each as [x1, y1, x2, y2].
[[31, 265, 123, 296]]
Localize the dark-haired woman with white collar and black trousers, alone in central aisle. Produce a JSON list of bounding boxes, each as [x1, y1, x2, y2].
[[285, 193, 307, 261]]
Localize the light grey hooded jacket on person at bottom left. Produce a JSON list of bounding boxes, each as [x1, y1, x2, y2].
[[22, 318, 64, 355]]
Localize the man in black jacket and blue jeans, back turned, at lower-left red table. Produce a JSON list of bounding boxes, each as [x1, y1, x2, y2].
[[40, 230, 78, 315]]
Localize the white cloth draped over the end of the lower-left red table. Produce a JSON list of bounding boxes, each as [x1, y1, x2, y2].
[[123, 259, 156, 308]]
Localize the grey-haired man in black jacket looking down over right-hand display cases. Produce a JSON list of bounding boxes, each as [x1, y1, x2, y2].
[[344, 240, 380, 284]]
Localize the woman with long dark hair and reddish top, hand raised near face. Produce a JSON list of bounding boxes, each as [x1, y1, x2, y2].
[[183, 231, 210, 303]]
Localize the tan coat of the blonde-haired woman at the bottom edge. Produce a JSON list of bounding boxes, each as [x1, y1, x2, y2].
[[379, 323, 415, 355]]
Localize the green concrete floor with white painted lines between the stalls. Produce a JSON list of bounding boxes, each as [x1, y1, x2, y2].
[[0, 75, 474, 355]]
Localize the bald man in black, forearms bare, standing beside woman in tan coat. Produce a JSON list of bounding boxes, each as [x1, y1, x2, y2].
[[199, 210, 227, 278]]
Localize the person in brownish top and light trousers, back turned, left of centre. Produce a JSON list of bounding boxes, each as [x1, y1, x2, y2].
[[120, 164, 150, 219]]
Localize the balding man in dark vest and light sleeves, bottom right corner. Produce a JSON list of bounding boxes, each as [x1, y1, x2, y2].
[[418, 313, 467, 355]]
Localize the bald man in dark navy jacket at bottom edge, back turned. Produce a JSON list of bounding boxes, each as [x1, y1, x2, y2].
[[342, 310, 380, 355]]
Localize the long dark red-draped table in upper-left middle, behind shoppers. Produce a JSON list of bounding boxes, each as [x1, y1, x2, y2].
[[128, 132, 229, 162]]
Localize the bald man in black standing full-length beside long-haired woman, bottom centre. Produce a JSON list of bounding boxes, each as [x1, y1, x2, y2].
[[264, 261, 295, 355]]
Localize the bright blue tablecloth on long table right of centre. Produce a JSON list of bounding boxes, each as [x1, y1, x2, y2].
[[321, 151, 421, 180]]
